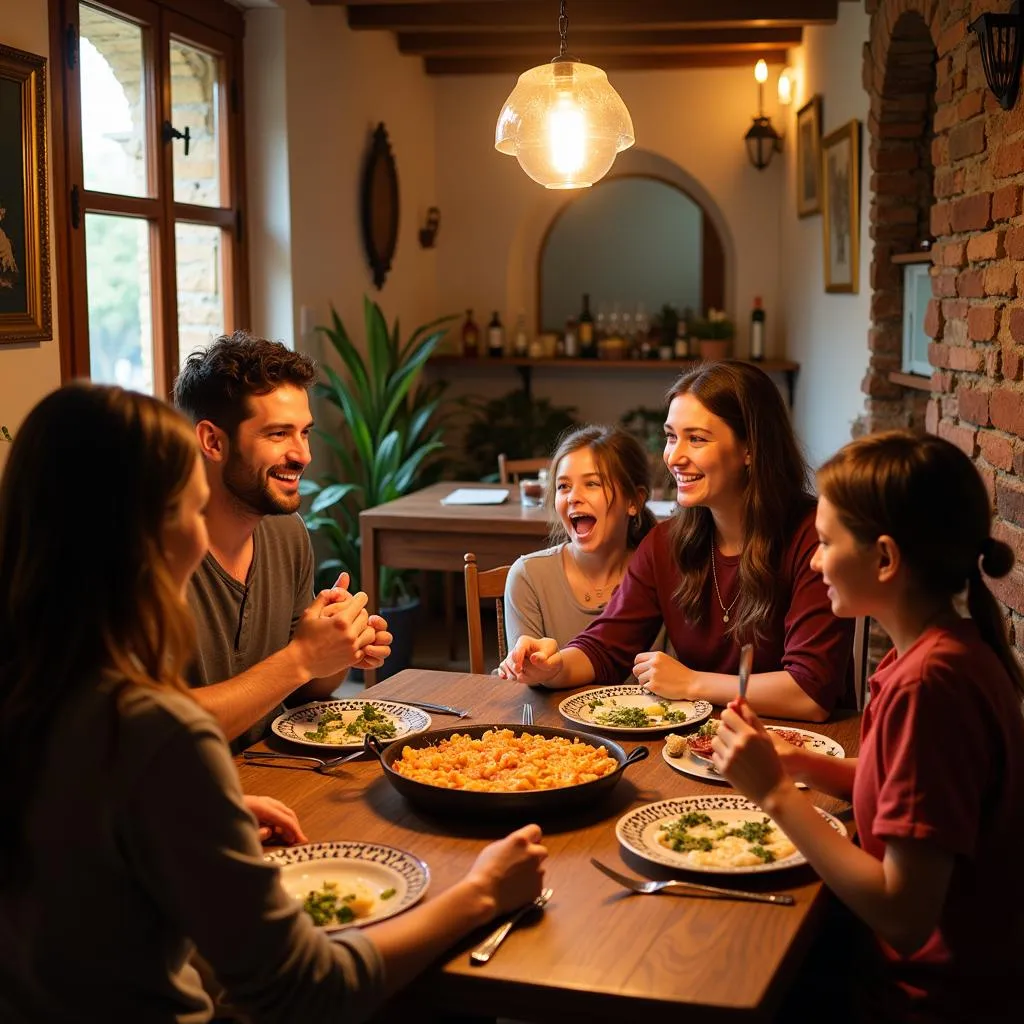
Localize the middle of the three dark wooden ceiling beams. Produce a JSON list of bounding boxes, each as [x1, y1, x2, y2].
[[398, 29, 803, 59]]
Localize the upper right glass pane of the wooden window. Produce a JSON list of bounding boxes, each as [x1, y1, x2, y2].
[[171, 39, 221, 206]]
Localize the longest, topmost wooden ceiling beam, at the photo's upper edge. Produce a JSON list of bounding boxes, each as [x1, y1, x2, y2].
[[347, 0, 839, 33]]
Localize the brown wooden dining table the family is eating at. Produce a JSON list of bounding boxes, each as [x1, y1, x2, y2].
[[240, 669, 859, 1024]]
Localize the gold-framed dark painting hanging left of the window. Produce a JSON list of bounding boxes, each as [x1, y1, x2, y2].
[[0, 46, 53, 344]]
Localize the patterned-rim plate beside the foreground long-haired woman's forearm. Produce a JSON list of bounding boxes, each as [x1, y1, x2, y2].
[[264, 842, 430, 932]]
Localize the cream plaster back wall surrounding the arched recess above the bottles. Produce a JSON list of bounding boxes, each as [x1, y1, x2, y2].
[[436, 65, 784, 421]]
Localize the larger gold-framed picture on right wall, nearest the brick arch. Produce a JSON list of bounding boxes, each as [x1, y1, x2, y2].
[[821, 119, 860, 293]]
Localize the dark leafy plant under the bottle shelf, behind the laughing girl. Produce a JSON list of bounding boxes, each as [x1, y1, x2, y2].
[[459, 388, 578, 480]]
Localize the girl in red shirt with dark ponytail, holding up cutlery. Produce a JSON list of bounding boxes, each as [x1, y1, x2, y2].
[[714, 431, 1024, 1021]]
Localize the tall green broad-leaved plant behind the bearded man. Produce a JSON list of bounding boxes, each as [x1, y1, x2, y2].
[[300, 298, 454, 607]]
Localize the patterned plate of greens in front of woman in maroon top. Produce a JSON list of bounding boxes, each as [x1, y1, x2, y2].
[[558, 685, 712, 735]]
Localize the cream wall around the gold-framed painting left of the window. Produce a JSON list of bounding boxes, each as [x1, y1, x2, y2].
[[0, 0, 60, 470]]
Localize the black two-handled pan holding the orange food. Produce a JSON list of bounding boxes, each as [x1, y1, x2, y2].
[[366, 723, 650, 818]]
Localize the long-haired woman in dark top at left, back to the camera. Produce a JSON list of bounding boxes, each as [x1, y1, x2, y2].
[[0, 384, 546, 1024]]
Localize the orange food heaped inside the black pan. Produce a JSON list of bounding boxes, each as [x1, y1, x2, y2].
[[391, 729, 618, 793]]
